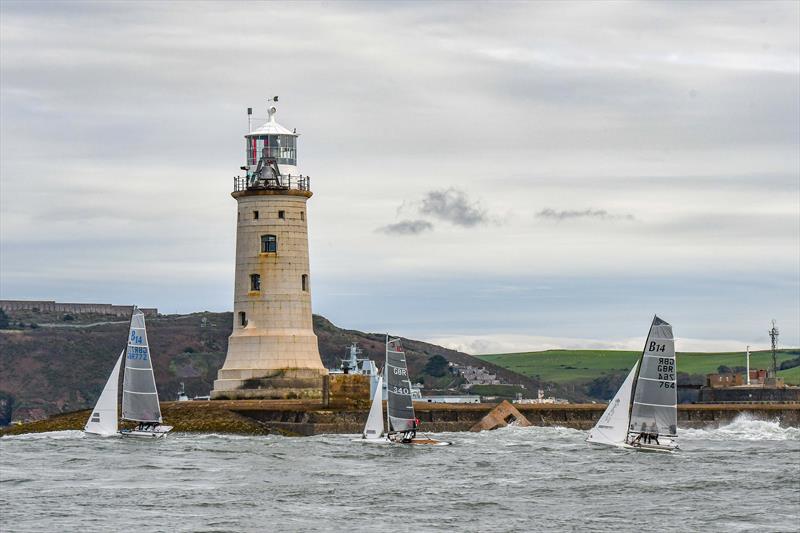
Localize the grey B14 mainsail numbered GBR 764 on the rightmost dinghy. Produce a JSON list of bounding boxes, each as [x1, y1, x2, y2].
[[628, 317, 678, 437]]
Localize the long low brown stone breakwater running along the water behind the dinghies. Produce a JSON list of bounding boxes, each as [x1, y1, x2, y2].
[[6, 400, 800, 436]]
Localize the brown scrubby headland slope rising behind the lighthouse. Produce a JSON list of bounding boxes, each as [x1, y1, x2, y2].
[[0, 313, 535, 425]]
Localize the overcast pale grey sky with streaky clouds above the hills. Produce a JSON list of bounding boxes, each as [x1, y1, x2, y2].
[[0, 0, 800, 353]]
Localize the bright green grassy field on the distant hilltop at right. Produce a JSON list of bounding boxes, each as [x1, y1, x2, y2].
[[476, 349, 800, 384]]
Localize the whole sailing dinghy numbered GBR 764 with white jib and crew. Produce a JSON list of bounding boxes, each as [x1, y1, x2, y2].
[[586, 316, 678, 452]]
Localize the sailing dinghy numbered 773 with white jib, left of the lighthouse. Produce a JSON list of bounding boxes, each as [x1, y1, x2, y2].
[[84, 307, 172, 438]]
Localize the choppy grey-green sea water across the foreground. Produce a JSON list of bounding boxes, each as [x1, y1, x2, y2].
[[0, 418, 800, 532]]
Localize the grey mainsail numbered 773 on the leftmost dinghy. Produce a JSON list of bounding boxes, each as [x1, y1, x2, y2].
[[122, 308, 161, 423]]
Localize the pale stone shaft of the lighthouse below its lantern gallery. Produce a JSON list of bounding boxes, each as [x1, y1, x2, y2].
[[213, 190, 327, 398]]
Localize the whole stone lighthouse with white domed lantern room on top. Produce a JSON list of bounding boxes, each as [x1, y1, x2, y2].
[[211, 101, 328, 399]]
